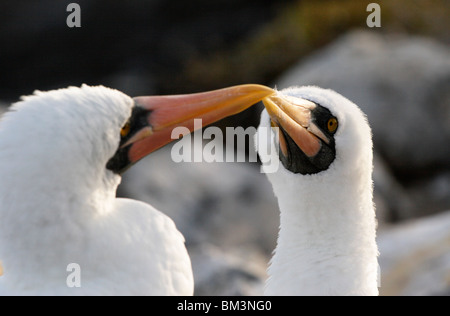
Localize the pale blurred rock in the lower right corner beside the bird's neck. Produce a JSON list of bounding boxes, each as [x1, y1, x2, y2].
[[378, 211, 450, 296]]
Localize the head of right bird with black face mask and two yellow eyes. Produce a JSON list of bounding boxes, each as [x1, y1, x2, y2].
[[258, 86, 372, 175]]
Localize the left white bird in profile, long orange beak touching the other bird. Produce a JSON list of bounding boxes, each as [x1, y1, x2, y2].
[[0, 85, 272, 295]]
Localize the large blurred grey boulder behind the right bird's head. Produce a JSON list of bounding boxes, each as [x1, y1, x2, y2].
[[276, 31, 450, 175]]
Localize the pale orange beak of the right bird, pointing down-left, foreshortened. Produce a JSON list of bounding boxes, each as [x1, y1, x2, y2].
[[263, 94, 329, 157]]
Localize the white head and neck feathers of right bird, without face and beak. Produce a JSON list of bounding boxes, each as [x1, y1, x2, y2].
[[257, 87, 378, 295]]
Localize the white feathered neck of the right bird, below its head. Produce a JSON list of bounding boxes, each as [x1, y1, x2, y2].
[[266, 168, 378, 295]]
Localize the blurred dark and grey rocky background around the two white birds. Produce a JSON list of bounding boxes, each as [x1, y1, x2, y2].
[[0, 0, 450, 295]]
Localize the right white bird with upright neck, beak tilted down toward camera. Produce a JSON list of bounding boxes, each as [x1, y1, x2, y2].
[[256, 86, 378, 295]]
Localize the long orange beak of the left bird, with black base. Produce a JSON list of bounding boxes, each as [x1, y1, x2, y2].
[[108, 84, 275, 173]]
